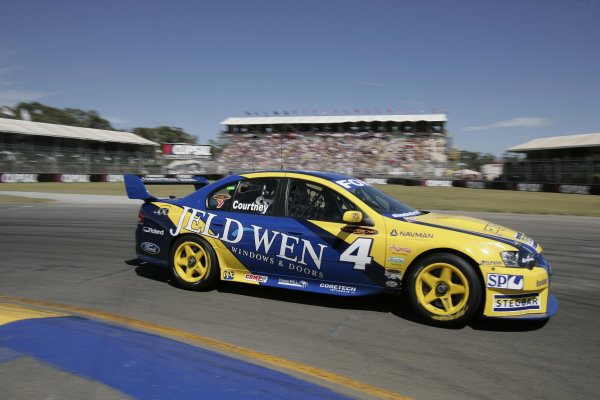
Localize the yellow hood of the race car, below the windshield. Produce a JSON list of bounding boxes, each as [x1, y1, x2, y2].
[[392, 212, 542, 253]]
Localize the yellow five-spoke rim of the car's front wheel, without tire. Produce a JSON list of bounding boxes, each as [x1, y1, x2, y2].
[[415, 262, 469, 316]]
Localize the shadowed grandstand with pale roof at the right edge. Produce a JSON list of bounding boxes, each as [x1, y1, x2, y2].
[[503, 133, 600, 185]]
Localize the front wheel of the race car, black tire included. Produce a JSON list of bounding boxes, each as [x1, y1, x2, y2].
[[407, 253, 483, 327]]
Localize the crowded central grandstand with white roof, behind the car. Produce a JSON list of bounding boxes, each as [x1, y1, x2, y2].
[[216, 114, 450, 177]]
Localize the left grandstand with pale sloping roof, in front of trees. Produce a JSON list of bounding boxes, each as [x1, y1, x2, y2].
[[0, 118, 160, 174]]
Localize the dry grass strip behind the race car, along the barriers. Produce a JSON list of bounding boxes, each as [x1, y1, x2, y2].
[[0, 182, 600, 216]]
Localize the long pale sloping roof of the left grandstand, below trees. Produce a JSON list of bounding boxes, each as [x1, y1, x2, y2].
[[0, 118, 159, 146]]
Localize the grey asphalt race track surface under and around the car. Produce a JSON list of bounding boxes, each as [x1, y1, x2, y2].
[[0, 197, 600, 400]]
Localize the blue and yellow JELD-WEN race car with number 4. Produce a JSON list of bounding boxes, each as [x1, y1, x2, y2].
[[125, 171, 558, 326]]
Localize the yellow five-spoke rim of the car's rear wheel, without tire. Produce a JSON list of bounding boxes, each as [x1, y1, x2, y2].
[[173, 240, 211, 283]]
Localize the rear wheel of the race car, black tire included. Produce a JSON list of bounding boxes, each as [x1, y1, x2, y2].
[[169, 235, 219, 290]]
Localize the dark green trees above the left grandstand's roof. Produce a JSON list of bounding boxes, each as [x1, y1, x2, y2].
[[13, 102, 115, 130]]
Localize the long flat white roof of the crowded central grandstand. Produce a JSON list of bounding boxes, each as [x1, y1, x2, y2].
[[221, 114, 448, 125]]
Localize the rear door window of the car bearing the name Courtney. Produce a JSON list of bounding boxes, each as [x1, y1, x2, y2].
[[231, 179, 279, 215]]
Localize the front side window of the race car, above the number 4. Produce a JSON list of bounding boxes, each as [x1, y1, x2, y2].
[[287, 179, 356, 222]]
